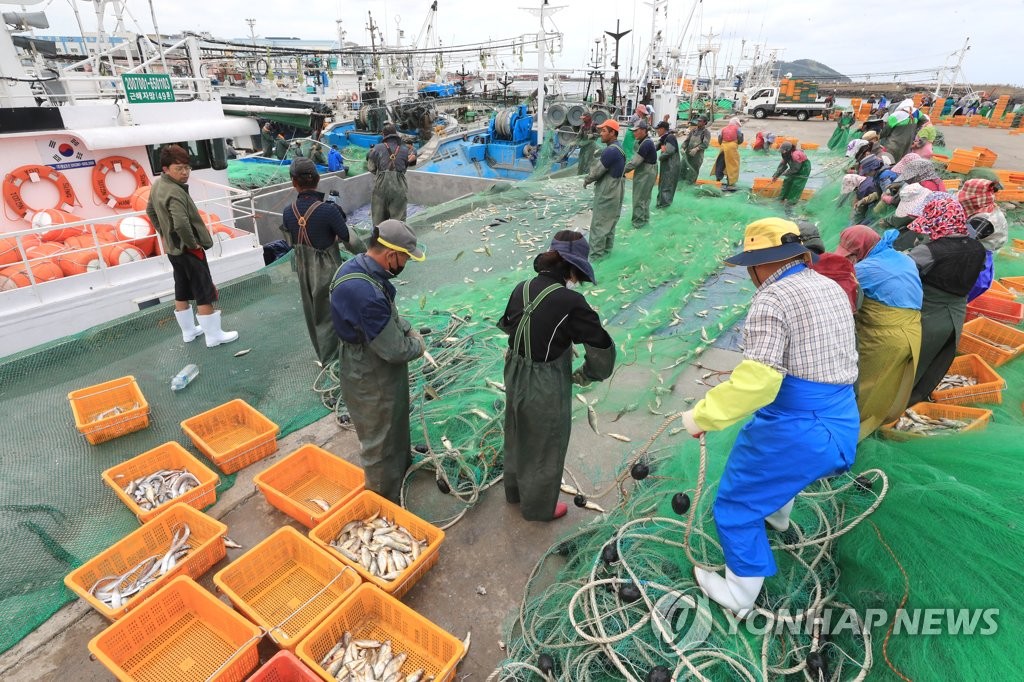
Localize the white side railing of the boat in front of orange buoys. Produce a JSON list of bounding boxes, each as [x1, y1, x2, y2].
[[0, 178, 259, 297]]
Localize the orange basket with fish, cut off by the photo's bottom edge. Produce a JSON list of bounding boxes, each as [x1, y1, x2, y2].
[[296, 583, 464, 682]]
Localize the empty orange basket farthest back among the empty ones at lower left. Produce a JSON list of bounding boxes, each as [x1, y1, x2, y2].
[[181, 399, 281, 473]]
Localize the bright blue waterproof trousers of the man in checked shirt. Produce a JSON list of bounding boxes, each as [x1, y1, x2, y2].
[[713, 377, 860, 578]]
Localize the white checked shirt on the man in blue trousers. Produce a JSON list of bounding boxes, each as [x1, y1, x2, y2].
[[743, 262, 857, 385]]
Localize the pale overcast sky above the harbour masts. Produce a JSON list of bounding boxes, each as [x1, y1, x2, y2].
[[28, 0, 1024, 85]]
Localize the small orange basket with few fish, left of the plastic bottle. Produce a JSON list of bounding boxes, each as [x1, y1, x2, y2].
[[68, 376, 150, 445]]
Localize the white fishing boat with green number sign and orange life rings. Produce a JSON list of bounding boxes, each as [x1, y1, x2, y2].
[[0, 3, 263, 354]]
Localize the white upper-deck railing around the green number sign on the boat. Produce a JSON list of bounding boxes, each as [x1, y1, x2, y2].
[[46, 36, 214, 104]]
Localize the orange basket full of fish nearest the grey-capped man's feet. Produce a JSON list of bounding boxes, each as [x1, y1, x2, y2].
[[309, 491, 444, 598]]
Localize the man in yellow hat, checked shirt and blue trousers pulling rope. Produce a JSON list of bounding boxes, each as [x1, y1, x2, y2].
[[683, 218, 860, 617]]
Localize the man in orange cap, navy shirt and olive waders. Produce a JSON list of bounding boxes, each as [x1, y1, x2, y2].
[[583, 119, 626, 258]]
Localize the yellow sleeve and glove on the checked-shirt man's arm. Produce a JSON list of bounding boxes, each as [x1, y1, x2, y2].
[[690, 359, 782, 433]]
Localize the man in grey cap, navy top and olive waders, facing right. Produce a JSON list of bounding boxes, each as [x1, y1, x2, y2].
[[331, 220, 426, 502]]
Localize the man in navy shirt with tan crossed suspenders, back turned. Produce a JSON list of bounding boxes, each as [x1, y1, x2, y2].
[[282, 159, 366, 367]]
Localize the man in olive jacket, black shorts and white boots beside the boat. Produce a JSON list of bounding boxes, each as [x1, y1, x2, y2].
[[145, 144, 239, 348]]
